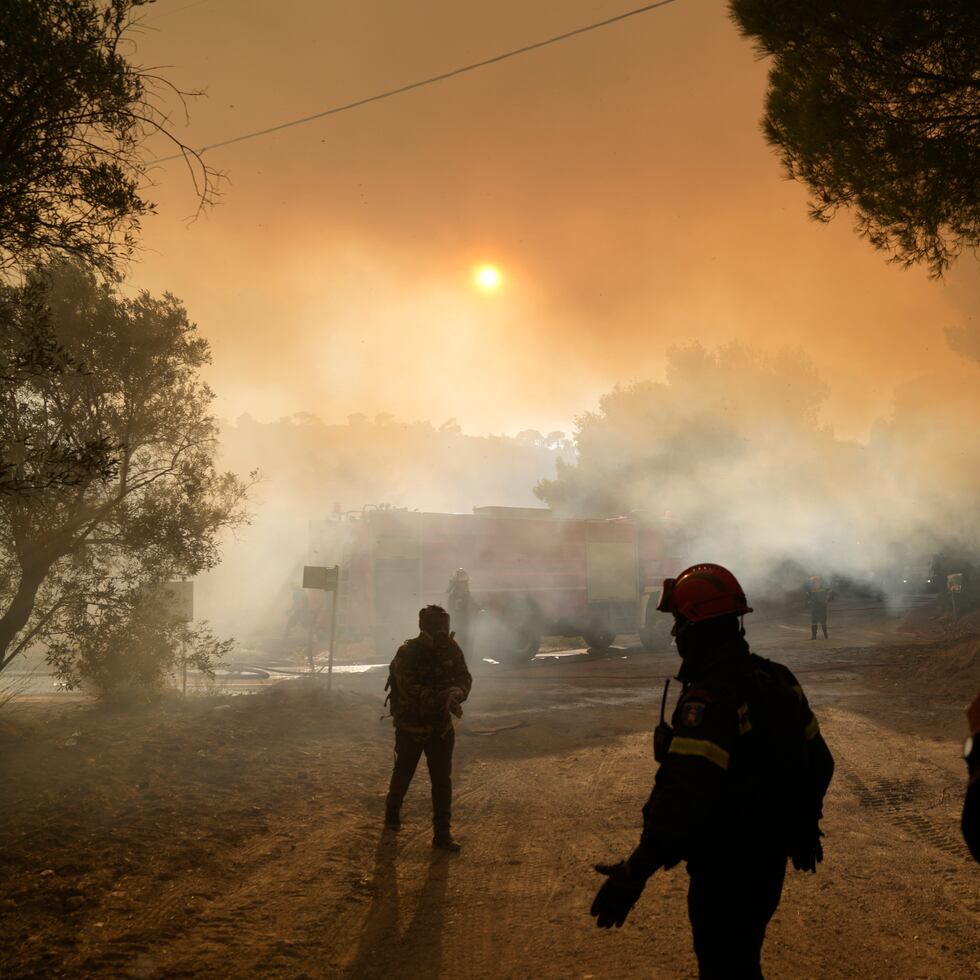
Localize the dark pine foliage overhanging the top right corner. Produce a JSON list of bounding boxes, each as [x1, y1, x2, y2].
[[730, 0, 980, 275]]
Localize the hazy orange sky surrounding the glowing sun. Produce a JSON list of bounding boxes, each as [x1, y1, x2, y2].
[[131, 0, 976, 437]]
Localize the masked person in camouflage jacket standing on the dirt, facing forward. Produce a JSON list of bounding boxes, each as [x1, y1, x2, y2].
[[385, 606, 473, 851]]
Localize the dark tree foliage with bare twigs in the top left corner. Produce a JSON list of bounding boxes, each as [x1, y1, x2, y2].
[[0, 0, 216, 271]]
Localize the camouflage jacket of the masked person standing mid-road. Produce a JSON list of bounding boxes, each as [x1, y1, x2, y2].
[[391, 633, 473, 735]]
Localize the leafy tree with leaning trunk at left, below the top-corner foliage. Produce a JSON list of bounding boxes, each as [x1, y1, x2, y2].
[[0, 262, 253, 688]]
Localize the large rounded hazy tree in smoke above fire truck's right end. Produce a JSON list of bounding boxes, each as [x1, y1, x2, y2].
[[535, 344, 829, 518]]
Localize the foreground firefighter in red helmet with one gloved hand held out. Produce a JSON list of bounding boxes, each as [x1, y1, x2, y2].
[[592, 564, 834, 978]]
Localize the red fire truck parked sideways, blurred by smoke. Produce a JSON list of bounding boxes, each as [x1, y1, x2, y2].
[[309, 507, 680, 663]]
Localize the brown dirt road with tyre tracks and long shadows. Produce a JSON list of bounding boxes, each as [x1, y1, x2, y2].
[[0, 619, 980, 978]]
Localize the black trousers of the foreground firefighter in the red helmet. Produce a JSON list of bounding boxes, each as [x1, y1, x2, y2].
[[687, 853, 786, 980]]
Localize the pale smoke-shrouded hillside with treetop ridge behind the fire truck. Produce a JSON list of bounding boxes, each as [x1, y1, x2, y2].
[[196, 414, 571, 645]]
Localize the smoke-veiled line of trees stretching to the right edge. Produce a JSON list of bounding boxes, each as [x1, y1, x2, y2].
[[536, 344, 980, 592]]
